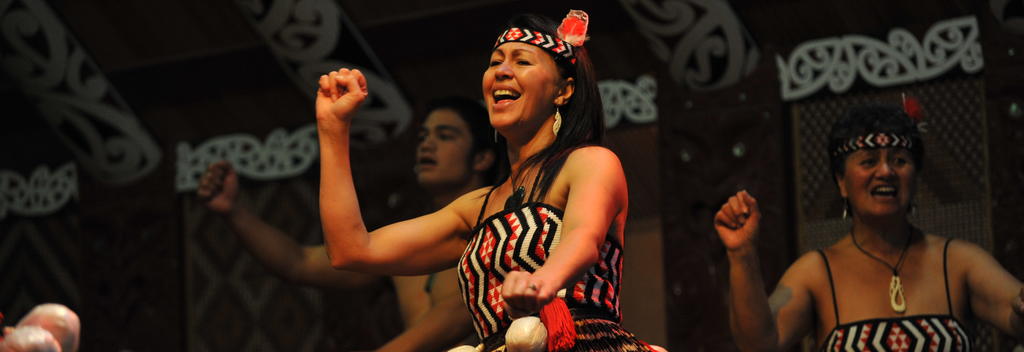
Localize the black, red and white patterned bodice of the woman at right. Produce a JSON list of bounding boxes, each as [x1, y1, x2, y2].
[[821, 315, 971, 352]]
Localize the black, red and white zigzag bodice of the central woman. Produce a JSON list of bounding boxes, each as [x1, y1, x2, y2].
[[458, 203, 623, 339]]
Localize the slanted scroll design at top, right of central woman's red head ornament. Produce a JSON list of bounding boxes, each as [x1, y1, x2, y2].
[[620, 0, 760, 91]]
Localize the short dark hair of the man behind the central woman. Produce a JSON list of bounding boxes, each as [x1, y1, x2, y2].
[[427, 96, 508, 185]]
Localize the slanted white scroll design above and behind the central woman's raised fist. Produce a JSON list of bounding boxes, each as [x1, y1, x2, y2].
[[237, 0, 413, 146]]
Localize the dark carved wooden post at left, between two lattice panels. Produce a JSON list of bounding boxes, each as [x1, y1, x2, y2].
[[79, 168, 184, 351]]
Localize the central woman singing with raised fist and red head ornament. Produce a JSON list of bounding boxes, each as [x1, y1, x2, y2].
[[316, 10, 649, 351]]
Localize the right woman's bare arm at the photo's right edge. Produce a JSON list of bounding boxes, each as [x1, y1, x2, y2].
[[949, 241, 1024, 339]]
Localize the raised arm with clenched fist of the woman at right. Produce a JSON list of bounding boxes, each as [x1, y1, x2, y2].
[[715, 191, 813, 351]]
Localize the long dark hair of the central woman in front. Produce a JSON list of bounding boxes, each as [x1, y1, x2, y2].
[[502, 14, 604, 201]]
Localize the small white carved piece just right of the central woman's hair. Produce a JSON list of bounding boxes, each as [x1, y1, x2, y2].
[[597, 75, 657, 129]]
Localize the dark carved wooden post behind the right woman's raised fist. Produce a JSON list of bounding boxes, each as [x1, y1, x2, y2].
[[658, 55, 794, 351]]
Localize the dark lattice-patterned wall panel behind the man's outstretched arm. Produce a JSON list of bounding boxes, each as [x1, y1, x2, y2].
[[182, 178, 401, 351]]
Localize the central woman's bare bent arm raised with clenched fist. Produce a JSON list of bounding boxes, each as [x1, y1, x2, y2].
[[316, 69, 481, 275]]
